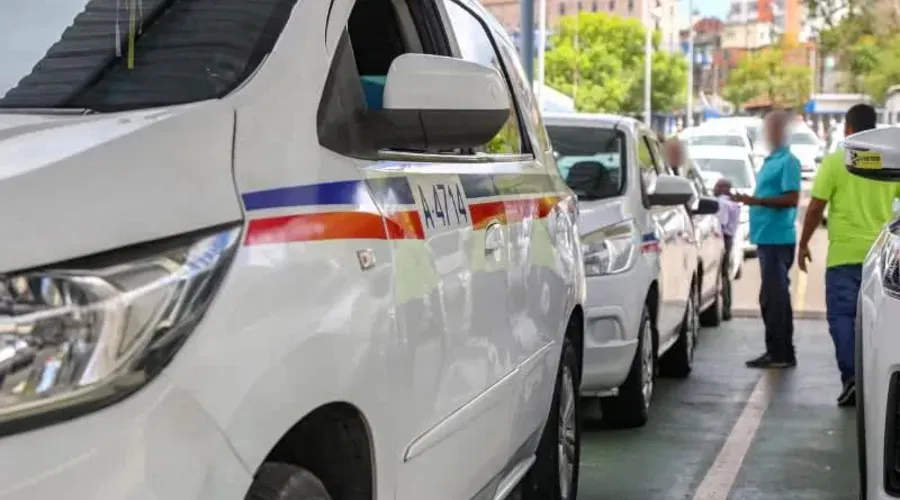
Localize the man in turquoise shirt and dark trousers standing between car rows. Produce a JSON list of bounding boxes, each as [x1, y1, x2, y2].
[[732, 111, 801, 368]]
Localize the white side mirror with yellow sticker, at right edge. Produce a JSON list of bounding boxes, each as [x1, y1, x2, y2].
[[844, 127, 900, 182]]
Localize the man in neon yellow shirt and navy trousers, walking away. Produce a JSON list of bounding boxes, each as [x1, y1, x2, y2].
[[797, 104, 900, 406]]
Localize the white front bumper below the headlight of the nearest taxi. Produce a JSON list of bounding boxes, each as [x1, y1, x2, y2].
[[0, 374, 252, 500]]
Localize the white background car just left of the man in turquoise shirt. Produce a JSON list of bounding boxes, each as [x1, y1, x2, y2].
[[689, 146, 756, 256]]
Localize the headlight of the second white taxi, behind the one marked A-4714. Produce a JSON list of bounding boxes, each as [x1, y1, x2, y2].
[[581, 220, 640, 276]]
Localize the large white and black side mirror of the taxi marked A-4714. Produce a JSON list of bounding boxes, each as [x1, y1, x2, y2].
[[364, 54, 511, 151]]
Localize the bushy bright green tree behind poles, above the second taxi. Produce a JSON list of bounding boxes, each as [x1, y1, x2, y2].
[[545, 12, 687, 113]]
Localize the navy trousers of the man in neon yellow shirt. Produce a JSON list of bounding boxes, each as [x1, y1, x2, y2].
[[825, 264, 862, 383]]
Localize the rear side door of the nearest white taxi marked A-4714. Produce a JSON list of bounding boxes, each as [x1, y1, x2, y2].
[[486, 7, 579, 460]]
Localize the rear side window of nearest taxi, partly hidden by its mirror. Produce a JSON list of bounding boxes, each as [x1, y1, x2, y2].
[[445, 0, 523, 154]]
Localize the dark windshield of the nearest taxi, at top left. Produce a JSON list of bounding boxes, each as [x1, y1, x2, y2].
[[0, 0, 296, 111]]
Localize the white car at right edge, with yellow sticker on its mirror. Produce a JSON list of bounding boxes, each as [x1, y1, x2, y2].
[[844, 128, 900, 500]]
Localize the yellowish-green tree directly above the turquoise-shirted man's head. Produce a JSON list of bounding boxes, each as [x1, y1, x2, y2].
[[722, 43, 812, 107]]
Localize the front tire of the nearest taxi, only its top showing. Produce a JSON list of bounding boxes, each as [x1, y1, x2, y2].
[[244, 462, 331, 500]]
